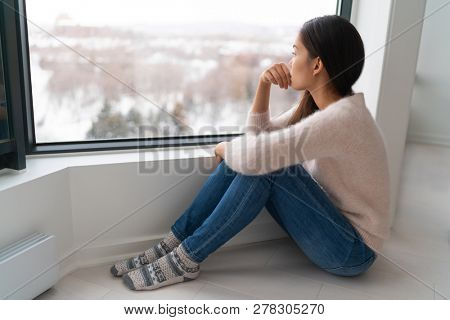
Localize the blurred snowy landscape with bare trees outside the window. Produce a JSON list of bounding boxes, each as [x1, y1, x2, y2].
[[23, 0, 334, 143]]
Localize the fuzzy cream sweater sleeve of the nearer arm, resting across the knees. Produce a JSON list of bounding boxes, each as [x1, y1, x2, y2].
[[224, 106, 357, 175]]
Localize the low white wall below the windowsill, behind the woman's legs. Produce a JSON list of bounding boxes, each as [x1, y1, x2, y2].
[[0, 151, 287, 277]]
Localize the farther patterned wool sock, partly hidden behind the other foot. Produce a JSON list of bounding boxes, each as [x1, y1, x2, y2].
[[111, 230, 181, 277]]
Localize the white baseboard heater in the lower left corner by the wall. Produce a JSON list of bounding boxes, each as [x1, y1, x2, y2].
[[0, 233, 59, 300]]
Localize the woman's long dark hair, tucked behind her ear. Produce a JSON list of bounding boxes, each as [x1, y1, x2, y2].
[[288, 15, 365, 124]]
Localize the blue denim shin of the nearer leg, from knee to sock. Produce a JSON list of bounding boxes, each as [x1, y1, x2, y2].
[[182, 173, 271, 263]]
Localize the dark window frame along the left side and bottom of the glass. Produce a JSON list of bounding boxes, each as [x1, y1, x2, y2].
[[0, 0, 352, 165]]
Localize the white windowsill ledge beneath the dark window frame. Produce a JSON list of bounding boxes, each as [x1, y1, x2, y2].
[[0, 145, 215, 192]]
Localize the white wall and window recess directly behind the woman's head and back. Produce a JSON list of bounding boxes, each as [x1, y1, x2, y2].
[[354, 0, 426, 226]]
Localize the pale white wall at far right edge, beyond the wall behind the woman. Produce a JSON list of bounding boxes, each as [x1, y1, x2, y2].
[[408, 0, 450, 146]]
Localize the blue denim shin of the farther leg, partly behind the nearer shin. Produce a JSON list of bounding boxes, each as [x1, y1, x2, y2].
[[171, 161, 237, 241]]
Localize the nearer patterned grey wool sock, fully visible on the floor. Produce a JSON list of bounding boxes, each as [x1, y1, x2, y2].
[[123, 244, 200, 290]]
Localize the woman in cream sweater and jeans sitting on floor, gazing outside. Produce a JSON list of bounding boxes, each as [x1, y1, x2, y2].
[[111, 15, 389, 290]]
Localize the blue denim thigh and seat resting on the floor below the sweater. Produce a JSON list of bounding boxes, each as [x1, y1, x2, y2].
[[266, 164, 371, 275]]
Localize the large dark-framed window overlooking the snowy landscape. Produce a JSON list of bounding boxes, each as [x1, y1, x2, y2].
[[0, 0, 351, 168]]
